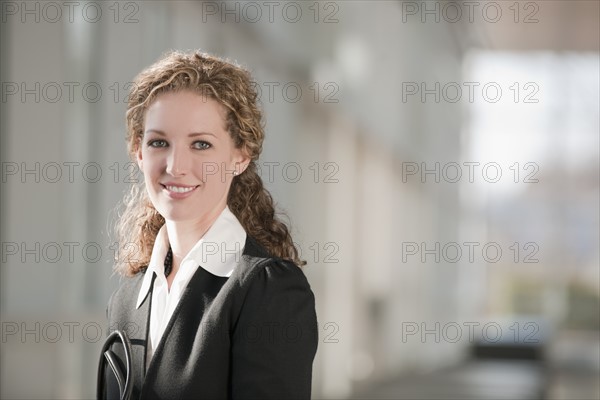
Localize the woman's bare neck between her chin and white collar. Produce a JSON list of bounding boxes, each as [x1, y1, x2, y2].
[[165, 203, 225, 277]]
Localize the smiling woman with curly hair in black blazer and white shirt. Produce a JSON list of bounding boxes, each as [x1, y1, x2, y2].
[[106, 52, 318, 399]]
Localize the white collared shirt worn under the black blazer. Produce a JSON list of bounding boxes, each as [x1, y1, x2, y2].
[[136, 206, 246, 364]]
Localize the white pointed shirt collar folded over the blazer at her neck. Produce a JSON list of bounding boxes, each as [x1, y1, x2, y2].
[[136, 206, 246, 308]]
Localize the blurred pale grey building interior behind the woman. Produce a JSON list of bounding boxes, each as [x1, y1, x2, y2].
[[0, 0, 600, 399]]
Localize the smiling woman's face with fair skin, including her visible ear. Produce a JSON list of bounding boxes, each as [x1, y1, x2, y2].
[[137, 91, 248, 222]]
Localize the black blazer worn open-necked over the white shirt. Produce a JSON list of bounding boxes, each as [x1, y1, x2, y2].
[[106, 236, 318, 399]]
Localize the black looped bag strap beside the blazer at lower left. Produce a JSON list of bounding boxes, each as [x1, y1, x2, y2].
[[96, 330, 133, 400]]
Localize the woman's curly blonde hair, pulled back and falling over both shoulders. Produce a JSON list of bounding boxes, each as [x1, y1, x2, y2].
[[115, 52, 306, 276]]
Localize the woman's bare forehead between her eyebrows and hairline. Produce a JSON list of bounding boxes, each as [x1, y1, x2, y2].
[[144, 91, 227, 134]]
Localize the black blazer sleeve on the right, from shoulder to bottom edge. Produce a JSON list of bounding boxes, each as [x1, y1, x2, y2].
[[231, 261, 318, 399]]
